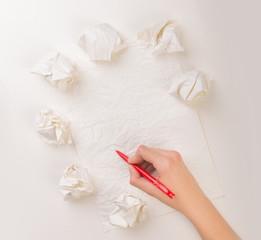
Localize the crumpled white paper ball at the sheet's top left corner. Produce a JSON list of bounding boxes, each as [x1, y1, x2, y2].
[[77, 23, 126, 62]]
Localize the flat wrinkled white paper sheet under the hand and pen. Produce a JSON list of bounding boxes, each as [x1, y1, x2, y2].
[[61, 39, 222, 231]]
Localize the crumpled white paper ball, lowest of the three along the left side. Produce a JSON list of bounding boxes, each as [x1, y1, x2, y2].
[[59, 163, 95, 201]]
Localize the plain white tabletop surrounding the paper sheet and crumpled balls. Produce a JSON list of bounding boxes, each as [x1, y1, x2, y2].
[[0, 0, 261, 240]]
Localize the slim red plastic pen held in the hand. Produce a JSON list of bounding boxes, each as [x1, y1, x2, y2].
[[116, 150, 175, 199]]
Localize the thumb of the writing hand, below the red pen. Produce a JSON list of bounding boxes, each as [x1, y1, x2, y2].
[[129, 164, 159, 196]]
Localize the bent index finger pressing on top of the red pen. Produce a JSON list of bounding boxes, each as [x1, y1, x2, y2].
[[128, 145, 162, 168]]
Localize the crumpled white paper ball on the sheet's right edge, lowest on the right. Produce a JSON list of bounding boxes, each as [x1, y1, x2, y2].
[[169, 70, 211, 104]]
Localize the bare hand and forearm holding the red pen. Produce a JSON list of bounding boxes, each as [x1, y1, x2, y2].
[[129, 145, 240, 240]]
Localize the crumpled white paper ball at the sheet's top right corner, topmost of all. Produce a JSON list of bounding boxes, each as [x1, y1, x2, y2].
[[138, 20, 184, 55]]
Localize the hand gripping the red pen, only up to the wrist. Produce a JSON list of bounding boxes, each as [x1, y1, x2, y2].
[[129, 145, 204, 214]]
